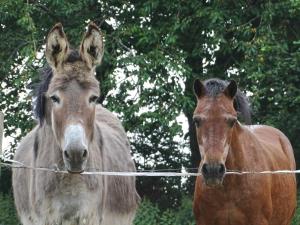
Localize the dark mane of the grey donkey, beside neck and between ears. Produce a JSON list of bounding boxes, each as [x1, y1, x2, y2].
[[32, 50, 81, 124]]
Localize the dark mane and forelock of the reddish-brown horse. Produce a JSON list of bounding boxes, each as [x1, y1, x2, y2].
[[204, 78, 251, 124]]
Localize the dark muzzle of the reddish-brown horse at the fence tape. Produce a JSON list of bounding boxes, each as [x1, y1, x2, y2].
[[201, 163, 226, 187]]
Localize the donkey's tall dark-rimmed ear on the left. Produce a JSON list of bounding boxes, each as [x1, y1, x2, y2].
[[45, 23, 69, 68]]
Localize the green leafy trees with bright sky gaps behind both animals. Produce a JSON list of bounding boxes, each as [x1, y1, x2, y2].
[[0, 0, 300, 209]]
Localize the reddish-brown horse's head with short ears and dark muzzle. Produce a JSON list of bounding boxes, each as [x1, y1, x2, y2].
[[193, 79, 250, 186]]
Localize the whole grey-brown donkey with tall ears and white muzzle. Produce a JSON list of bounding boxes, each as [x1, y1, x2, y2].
[[13, 23, 139, 225]]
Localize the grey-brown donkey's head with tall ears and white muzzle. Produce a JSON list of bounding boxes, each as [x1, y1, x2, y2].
[[45, 23, 103, 173]]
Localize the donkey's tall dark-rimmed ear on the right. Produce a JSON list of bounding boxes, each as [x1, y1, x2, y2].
[[80, 22, 103, 69]]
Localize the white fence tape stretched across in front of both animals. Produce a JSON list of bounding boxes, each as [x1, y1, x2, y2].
[[0, 155, 300, 177]]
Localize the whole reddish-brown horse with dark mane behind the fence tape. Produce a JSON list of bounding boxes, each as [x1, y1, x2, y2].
[[193, 79, 296, 225]]
